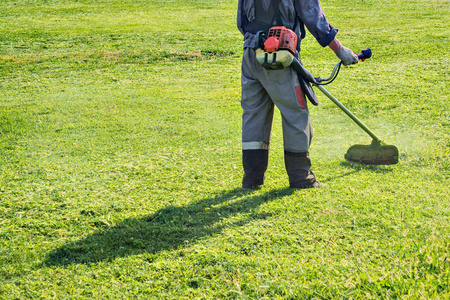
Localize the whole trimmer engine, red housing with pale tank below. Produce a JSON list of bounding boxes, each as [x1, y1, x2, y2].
[[255, 26, 297, 70]]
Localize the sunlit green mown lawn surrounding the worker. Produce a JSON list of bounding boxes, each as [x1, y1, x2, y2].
[[0, 0, 450, 299]]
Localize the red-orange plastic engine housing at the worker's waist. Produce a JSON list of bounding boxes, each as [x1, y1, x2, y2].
[[264, 26, 297, 54]]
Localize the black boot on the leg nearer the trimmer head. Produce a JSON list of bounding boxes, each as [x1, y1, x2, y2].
[[284, 150, 320, 189]]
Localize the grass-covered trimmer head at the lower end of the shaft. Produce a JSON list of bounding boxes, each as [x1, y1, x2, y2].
[[345, 140, 398, 165]]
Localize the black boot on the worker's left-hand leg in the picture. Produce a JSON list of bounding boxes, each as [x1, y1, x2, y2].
[[242, 149, 269, 190]]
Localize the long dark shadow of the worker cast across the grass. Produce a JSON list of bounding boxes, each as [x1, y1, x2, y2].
[[43, 188, 293, 266]]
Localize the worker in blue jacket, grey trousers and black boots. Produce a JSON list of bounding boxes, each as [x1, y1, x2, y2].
[[237, 0, 358, 190]]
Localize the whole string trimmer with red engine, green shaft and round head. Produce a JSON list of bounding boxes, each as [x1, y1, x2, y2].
[[255, 26, 398, 165]]
